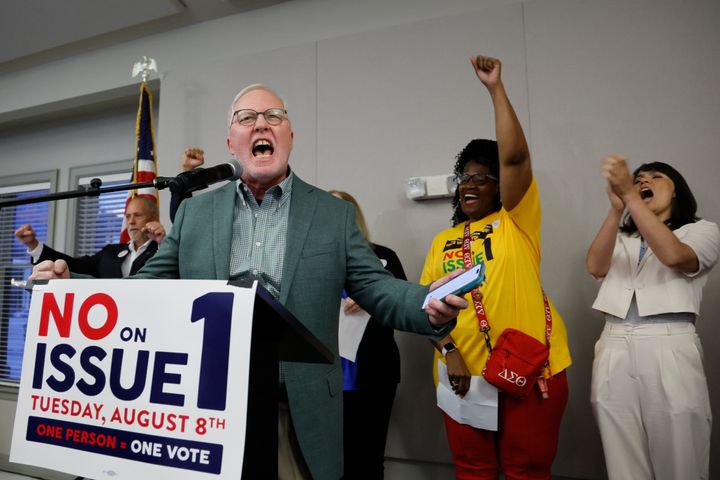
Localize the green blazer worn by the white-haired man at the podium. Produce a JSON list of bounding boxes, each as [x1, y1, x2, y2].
[[136, 176, 449, 480]]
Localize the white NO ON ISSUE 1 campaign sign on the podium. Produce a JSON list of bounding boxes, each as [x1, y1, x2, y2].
[[10, 280, 255, 480]]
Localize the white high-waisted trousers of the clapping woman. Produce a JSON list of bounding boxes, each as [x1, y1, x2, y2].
[[590, 322, 712, 480]]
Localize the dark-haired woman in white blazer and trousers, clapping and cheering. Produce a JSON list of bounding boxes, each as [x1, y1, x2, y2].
[[586, 155, 720, 480]]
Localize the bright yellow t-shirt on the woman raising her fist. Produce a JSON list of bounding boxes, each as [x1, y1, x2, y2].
[[420, 179, 572, 384]]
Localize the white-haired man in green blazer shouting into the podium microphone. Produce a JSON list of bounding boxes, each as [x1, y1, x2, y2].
[[34, 84, 467, 480]]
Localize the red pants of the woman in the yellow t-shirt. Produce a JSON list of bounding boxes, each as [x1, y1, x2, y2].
[[445, 371, 568, 480]]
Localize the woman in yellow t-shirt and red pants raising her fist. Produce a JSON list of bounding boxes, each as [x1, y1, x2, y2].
[[420, 56, 571, 479]]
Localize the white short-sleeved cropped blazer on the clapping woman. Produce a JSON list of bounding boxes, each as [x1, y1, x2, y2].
[[593, 220, 720, 318]]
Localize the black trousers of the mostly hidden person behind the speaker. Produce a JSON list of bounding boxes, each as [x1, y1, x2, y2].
[[343, 384, 397, 480]]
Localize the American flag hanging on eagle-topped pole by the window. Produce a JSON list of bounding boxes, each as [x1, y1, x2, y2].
[[120, 82, 159, 243]]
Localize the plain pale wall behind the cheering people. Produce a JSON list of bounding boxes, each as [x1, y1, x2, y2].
[[0, 0, 720, 478]]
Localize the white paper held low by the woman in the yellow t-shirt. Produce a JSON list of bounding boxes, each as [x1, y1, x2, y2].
[[437, 360, 498, 431]]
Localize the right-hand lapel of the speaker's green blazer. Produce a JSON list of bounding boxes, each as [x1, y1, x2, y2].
[[280, 175, 317, 305]]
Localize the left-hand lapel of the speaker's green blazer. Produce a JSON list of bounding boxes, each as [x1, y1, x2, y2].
[[212, 182, 237, 280]]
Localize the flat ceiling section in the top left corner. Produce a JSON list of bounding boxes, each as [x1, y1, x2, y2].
[[0, 0, 287, 71]]
